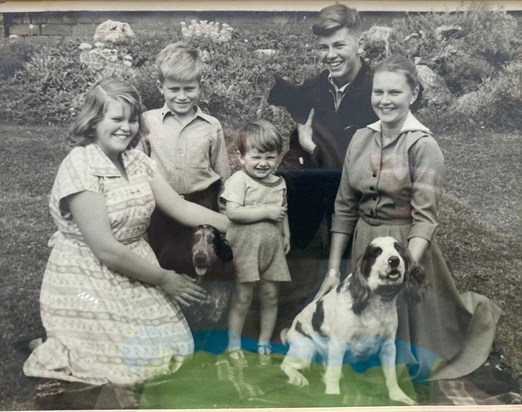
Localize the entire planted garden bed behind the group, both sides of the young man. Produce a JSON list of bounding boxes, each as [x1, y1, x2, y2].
[[0, 3, 522, 135]]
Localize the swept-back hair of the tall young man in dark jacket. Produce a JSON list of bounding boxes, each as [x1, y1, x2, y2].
[[312, 4, 361, 36]]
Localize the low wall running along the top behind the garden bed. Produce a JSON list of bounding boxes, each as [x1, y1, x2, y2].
[[0, 11, 403, 38]]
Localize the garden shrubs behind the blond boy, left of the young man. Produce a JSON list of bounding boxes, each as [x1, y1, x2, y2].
[[0, 27, 317, 134]]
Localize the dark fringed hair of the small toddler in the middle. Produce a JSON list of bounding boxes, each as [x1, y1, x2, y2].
[[237, 119, 283, 156]]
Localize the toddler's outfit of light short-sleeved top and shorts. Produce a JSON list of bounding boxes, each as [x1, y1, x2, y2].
[[221, 170, 290, 282]]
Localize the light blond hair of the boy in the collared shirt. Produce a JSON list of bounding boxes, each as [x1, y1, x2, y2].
[[156, 42, 203, 83]]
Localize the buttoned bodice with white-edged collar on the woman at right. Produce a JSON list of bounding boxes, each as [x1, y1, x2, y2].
[[332, 113, 444, 241]]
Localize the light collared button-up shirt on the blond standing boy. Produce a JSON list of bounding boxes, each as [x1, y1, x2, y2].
[[140, 104, 230, 194]]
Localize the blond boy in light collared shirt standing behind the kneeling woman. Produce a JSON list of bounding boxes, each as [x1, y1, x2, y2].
[[141, 43, 230, 267]]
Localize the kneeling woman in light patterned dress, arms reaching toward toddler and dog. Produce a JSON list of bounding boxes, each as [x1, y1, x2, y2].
[[24, 79, 228, 385]]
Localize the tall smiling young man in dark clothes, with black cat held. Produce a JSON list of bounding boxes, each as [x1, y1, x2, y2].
[[268, 4, 377, 327]]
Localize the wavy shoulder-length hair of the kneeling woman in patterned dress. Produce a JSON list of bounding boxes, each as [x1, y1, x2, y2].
[[67, 78, 145, 147]]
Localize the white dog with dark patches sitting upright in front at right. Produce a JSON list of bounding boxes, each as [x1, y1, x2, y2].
[[281, 236, 424, 405]]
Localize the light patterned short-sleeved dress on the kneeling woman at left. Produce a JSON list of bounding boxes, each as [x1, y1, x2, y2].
[[24, 144, 194, 384]]
